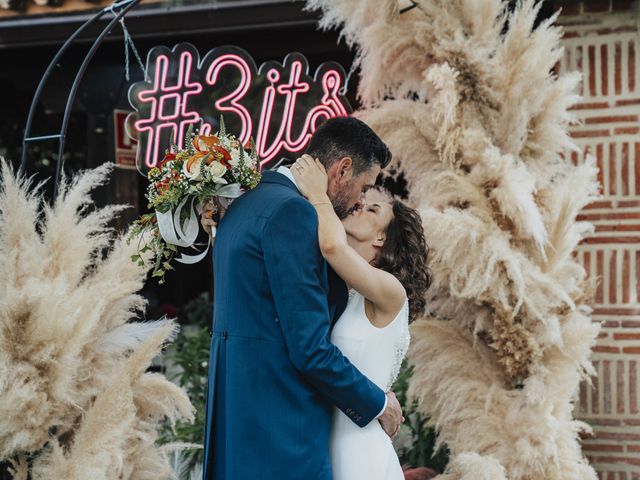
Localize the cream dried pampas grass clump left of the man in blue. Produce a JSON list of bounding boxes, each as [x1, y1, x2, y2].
[[0, 160, 194, 480]]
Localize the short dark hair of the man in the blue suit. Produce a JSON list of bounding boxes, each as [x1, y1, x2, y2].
[[306, 117, 391, 176]]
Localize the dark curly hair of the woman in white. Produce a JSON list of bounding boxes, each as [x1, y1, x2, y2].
[[375, 200, 431, 323]]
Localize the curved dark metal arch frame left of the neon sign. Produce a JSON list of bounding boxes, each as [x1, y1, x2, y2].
[[19, 0, 141, 202]]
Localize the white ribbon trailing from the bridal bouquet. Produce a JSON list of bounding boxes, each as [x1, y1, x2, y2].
[[156, 183, 243, 264]]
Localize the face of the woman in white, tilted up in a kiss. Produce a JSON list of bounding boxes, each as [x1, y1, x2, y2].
[[342, 202, 393, 262]]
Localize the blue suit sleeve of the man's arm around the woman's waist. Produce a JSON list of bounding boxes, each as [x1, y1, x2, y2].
[[263, 197, 386, 427]]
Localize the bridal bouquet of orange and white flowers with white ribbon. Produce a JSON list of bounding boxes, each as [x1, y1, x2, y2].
[[129, 120, 260, 283]]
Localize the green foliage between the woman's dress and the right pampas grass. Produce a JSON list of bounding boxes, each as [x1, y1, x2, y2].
[[392, 361, 449, 473]]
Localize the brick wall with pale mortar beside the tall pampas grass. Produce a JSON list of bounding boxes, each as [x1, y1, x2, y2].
[[560, 0, 640, 480]]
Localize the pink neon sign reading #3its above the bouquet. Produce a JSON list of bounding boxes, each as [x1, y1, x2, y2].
[[129, 43, 351, 173]]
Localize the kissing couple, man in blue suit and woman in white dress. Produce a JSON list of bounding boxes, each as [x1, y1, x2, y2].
[[201, 117, 430, 480]]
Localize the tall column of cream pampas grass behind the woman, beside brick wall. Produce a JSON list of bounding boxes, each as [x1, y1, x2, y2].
[[308, 0, 599, 480]]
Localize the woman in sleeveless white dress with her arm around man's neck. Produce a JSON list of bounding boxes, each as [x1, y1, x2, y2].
[[291, 155, 430, 480]]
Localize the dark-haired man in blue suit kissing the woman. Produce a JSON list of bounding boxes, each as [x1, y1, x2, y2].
[[204, 118, 402, 480]]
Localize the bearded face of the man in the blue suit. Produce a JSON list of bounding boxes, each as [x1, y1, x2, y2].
[[327, 157, 380, 219]]
